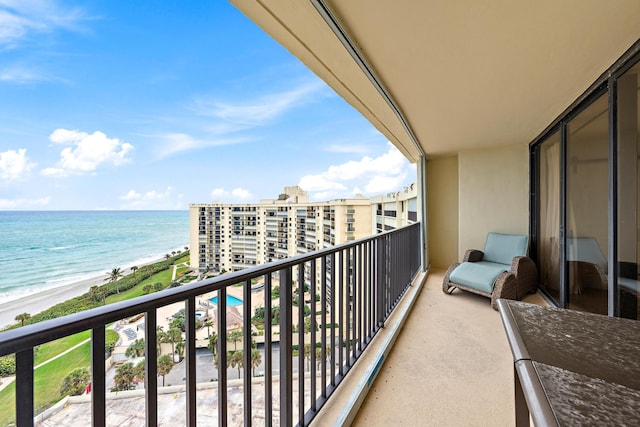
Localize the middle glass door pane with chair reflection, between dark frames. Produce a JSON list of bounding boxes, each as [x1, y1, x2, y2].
[[565, 94, 609, 314]]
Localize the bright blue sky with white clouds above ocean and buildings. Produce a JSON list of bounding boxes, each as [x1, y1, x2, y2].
[[0, 0, 415, 210]]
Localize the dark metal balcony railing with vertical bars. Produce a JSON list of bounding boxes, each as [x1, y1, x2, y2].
[[0, 223, 421, 426]]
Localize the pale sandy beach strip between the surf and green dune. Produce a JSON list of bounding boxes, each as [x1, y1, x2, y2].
[[0, 259, 162, 328]]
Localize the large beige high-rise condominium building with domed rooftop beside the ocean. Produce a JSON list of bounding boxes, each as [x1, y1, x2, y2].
[[190, 186, 375, 273]]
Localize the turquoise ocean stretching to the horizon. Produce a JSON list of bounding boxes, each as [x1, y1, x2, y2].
[[0, 211, 189, 303]]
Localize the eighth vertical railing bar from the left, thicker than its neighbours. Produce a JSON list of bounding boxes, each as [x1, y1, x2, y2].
[[280, 267, 293, 426]]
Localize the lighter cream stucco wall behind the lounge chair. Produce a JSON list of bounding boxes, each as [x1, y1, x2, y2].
[[458, 144, 529, 259]]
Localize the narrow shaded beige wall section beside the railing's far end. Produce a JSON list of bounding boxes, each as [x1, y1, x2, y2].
[[426, 156, 458, 267]]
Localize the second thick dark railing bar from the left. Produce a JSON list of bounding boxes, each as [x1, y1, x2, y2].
[[91, 325, 107, 427]]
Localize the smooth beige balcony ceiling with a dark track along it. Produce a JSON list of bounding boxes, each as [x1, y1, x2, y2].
[[231, 0, 640, 160]]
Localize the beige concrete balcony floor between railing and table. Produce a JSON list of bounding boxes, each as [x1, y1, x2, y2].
[[318, 270, 546, 427]]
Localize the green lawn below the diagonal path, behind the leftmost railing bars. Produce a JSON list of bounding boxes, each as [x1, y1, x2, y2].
[[0, 342, 91, 426]]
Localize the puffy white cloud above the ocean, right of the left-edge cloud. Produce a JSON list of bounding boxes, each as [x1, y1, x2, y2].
[[41, 129, 133, 177]]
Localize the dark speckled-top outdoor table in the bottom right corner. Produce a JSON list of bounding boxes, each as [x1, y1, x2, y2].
[[498, 299, 640, 427]]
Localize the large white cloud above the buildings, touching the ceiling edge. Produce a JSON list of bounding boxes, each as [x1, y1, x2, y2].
[[298, 143, 415, 200]]
